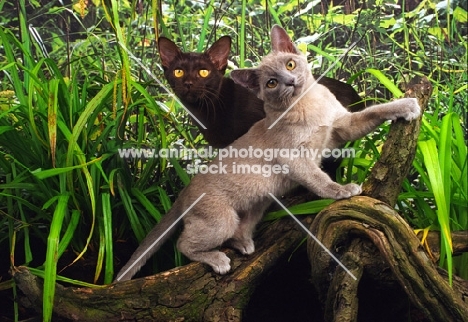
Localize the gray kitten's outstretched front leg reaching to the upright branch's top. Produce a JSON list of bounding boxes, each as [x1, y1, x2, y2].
[[332, 98, 421, 146]]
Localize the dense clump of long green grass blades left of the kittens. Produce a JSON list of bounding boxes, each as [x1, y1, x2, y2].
[[0, 3, 192, 321]]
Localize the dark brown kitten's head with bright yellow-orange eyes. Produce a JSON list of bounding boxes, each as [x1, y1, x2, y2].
[[158, 37, 231, 104]]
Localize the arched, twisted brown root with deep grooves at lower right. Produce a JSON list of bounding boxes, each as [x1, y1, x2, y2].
[[308, 196, 468, 321]]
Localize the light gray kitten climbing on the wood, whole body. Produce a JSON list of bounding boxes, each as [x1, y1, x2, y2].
[[117, 26, 420, 281]]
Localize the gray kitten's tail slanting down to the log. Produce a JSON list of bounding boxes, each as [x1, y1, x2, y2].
[[114, 202, 182, 282]]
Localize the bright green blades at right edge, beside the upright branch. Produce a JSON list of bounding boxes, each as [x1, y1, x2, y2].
[[400, 112, 468, 278]]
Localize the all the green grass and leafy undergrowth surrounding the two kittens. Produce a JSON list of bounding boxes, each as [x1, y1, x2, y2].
[[0, 0, 468, 321]]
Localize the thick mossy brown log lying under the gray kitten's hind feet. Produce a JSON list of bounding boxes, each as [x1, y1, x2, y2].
[[13, 219, 311, 322]]
